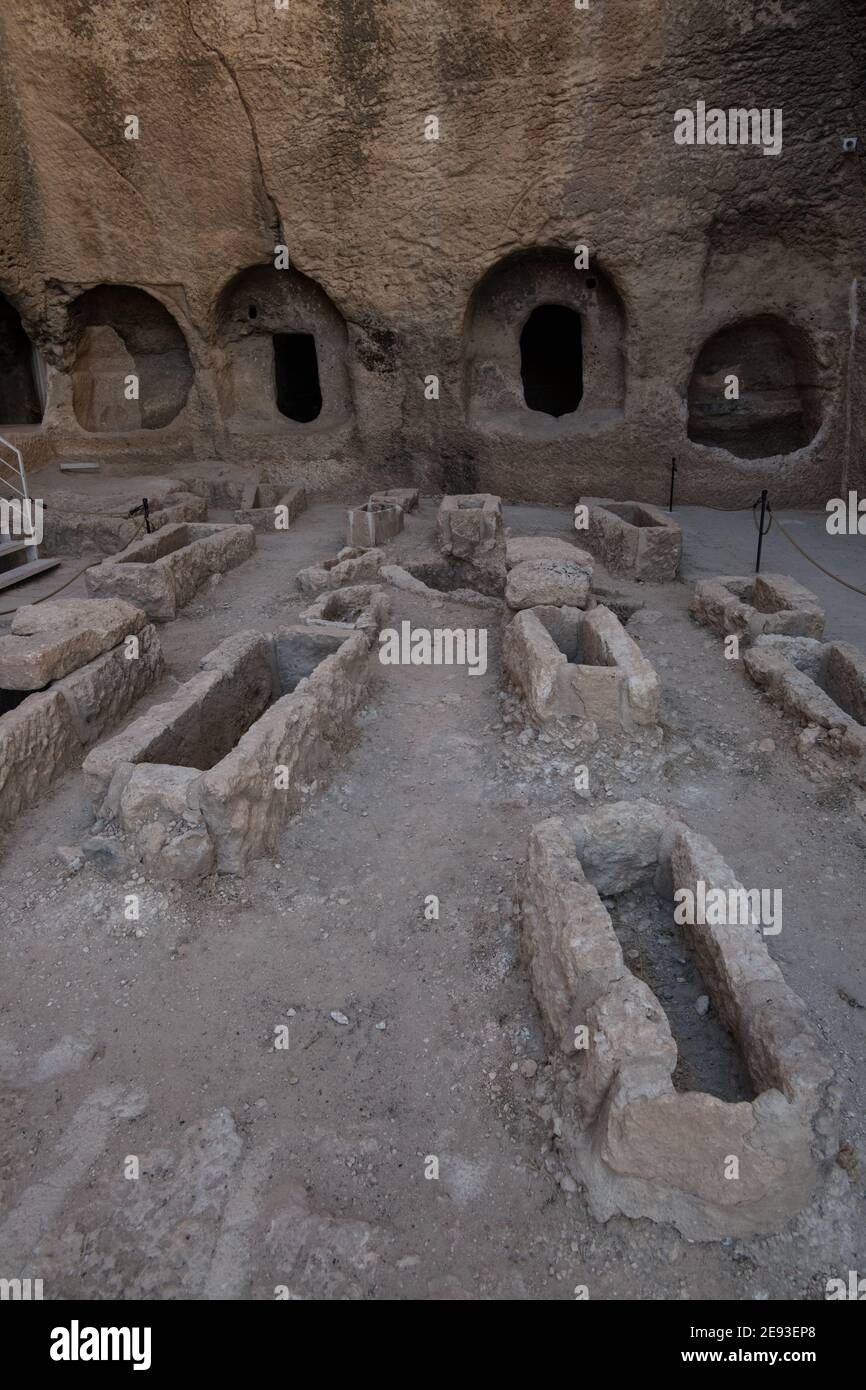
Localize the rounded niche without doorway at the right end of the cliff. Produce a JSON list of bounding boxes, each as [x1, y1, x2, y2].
[[688, 314, 822, 459]]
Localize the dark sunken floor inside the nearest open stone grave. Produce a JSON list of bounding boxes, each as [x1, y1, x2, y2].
[[603, 884, 756, 1101]]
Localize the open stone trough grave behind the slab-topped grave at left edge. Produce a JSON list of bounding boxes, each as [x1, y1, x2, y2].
[[85, 523, 256, 623]]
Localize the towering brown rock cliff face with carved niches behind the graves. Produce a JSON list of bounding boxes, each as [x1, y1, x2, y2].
[[0, 0, 866, 506]]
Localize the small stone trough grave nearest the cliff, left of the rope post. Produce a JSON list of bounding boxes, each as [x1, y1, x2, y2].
[[575, 498, 683, 584]]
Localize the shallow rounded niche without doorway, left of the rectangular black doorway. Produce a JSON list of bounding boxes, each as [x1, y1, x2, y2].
[[70, 285, 193, 434]]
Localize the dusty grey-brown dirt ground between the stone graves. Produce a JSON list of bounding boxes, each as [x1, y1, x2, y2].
[[0, 499, 866, 1300]]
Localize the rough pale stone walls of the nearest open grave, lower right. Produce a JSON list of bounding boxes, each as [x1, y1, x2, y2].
[[521, 802, 840, 1240]]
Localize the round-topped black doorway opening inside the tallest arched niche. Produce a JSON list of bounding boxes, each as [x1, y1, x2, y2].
[[520, 304, 584, 417]]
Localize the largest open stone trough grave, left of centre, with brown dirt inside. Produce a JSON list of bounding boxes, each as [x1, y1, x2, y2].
[[85, 592, 375, 878]]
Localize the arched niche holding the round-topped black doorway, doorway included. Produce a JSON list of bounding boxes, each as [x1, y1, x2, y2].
[[463, 247, 626, 438]]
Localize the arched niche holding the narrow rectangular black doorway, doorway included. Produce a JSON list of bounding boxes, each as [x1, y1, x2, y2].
[[217, 265, 352, 431]]
